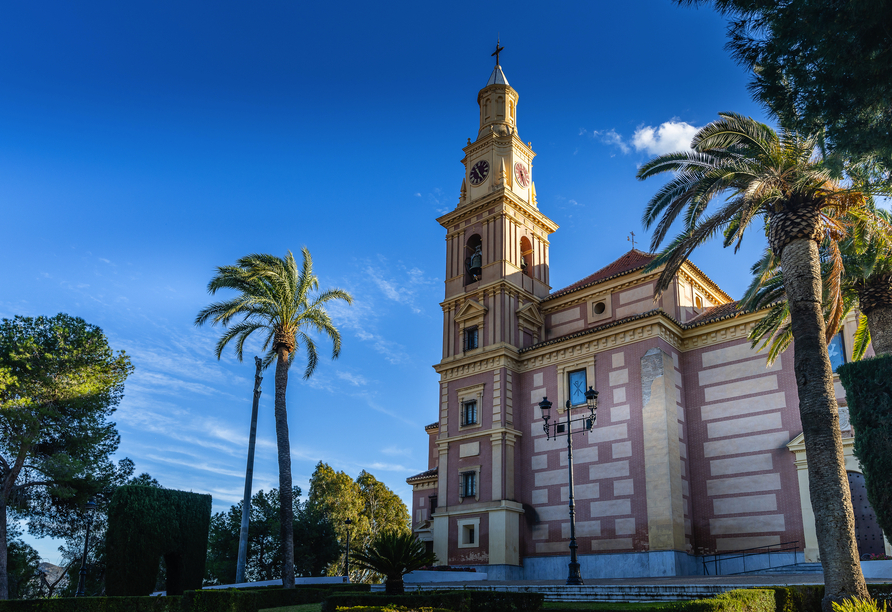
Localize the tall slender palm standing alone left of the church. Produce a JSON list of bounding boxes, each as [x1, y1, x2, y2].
[[195, 247, 353, 588]]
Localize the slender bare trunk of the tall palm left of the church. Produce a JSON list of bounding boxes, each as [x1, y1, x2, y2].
[[275, 346, 294, 589]]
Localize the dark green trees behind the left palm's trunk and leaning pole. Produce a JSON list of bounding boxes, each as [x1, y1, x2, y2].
[[206, 487, 341, 584]]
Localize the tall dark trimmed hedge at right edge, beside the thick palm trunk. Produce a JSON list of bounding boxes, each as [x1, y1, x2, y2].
[[837, 355, 892, 533]]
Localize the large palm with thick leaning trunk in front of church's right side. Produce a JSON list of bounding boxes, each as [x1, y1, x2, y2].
[[638, 113, 880, 610]]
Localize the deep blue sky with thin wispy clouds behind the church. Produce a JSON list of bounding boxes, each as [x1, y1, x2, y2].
[[0, 0, 765, 562]]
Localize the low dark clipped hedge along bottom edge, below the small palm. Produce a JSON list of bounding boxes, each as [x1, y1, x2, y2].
[[322, 591, 545, 612]]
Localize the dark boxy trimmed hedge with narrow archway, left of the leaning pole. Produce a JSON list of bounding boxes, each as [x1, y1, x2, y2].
[[105, 485, 211, 596]]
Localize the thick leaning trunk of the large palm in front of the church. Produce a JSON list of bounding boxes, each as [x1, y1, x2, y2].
[[781, 239, 869, 612]]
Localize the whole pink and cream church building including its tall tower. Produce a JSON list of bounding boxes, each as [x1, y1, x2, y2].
[[407, 58, 892, 579]]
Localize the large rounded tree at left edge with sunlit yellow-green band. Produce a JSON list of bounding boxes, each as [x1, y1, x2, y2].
[[0, 314, 133, 599]]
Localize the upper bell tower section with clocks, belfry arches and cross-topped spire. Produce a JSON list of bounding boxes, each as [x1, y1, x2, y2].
[[437, 51, 558, 362]]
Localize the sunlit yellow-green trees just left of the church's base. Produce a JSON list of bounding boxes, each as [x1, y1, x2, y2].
[[308, 461, 411, 582]]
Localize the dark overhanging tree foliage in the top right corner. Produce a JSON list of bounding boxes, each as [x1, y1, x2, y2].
[[675, 0, 892, 182]]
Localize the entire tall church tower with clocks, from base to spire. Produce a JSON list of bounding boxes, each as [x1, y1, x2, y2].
[[428, 48, 557, 578]]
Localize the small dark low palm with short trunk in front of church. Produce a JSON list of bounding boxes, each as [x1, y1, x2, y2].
[[350, 531, 437, 595]]
